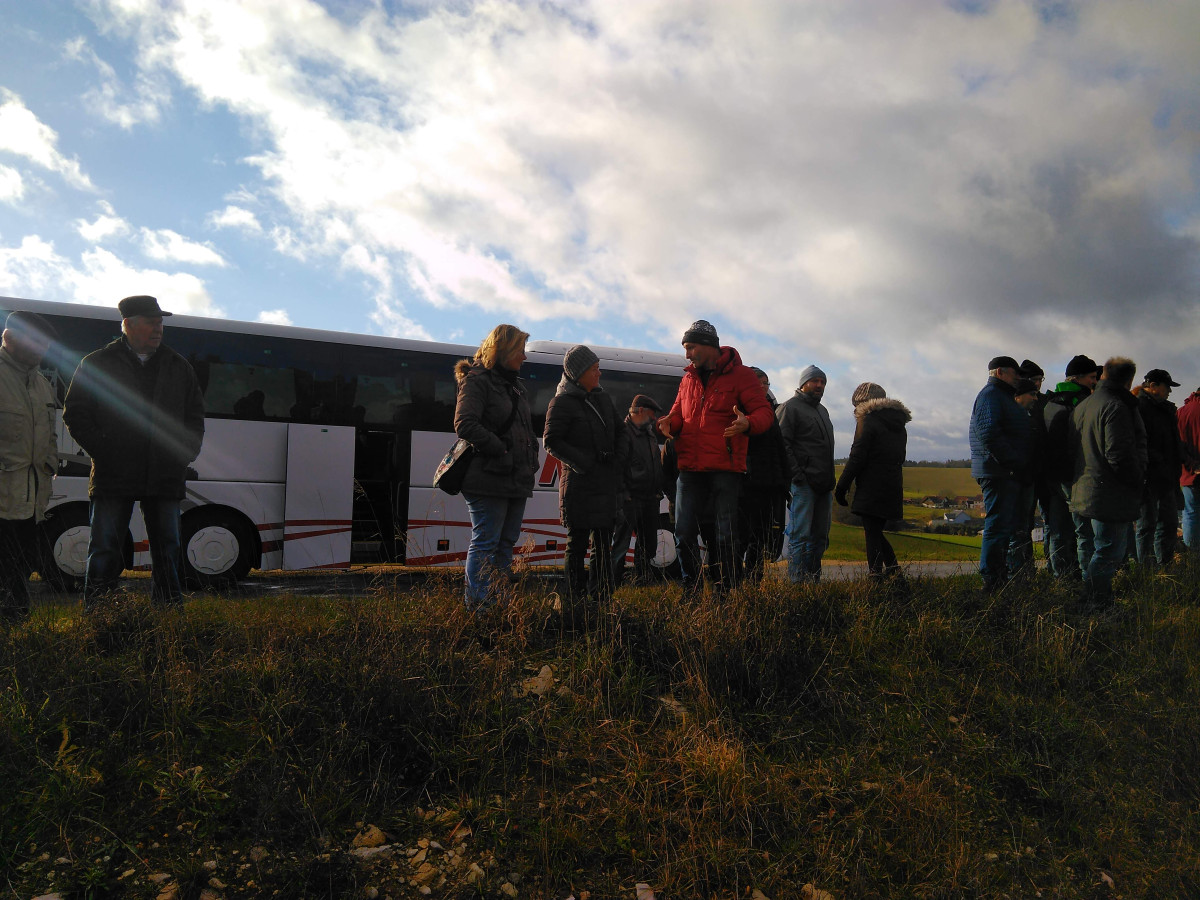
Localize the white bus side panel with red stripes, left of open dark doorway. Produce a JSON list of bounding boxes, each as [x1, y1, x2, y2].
[[283, 425, 354, 569]]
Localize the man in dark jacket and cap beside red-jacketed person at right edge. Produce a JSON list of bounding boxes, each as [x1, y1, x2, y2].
[[1136, 368, 1183, 569]]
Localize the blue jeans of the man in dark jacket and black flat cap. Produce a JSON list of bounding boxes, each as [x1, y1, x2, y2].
[[83, 497, 184, 604]]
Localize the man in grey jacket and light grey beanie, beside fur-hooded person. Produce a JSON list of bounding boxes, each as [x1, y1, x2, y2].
[[775, 366, 835, 583]]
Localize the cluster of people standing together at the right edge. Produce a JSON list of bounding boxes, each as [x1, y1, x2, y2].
[[970, 354, 1200, 608]]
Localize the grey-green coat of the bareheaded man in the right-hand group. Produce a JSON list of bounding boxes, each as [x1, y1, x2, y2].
[[1069, 382, 1146, 522]]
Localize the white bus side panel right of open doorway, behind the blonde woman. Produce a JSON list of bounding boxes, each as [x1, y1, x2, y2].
[[406, 431, 566, 565]]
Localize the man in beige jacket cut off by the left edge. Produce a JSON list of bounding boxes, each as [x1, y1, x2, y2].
[[0, 310, 59, 622]]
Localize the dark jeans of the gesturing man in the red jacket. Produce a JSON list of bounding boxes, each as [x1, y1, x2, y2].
[[676, 472, 744, 592]]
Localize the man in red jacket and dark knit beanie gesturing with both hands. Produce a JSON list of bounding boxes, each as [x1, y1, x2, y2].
[[659, 319, 774, 595]]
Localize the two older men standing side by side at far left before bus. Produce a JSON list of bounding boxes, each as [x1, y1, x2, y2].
[[0, 295, 204, 619]]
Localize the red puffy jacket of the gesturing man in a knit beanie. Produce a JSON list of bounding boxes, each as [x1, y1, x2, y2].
[[667, 347, 770, 472]]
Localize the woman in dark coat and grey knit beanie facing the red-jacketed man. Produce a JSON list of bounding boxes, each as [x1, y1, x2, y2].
[[544, 344, 629, 600]]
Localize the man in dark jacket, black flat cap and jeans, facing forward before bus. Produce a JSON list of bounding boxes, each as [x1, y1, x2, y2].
[[62, 295, 204, 607]]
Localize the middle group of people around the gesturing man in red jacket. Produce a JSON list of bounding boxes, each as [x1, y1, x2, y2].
[[455, 319, 912, 608]]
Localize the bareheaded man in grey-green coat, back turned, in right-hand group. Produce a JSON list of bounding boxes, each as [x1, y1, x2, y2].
[[1068, 356, 1147, 608]]
